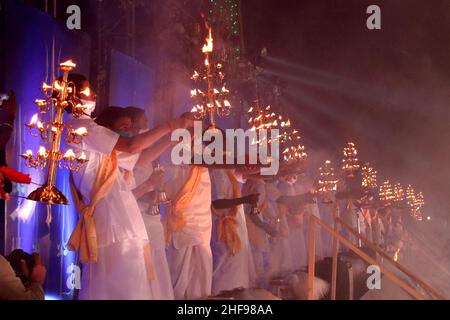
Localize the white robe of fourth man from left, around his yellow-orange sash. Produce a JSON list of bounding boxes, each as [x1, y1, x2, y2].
[[211, 170, 255, 295]]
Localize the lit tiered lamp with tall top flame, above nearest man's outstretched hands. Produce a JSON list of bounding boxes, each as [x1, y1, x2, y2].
[[191, 28, 231, 127]]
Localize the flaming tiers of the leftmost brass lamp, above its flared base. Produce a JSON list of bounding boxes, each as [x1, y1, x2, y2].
[[21, 60, 91, 171]]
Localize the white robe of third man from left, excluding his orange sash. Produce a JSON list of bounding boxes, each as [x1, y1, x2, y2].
[[165, 165, 213, 299]]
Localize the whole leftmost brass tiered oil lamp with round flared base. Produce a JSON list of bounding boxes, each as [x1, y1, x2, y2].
[[21, 60, 91, 205]]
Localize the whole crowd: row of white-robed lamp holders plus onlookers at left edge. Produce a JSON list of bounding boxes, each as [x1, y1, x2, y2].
[[0, 74, 412, 300]]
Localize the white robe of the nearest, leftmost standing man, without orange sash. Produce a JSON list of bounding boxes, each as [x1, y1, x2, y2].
[[72, 117, 154, 300]]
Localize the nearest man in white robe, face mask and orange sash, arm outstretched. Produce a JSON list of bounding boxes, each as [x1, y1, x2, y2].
[[67, 74, 192, 299]]
